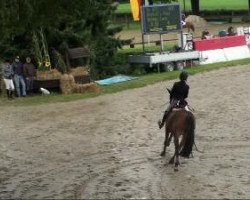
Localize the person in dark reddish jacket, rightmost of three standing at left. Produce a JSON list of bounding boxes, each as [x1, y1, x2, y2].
[[23, 57, 36, 93]]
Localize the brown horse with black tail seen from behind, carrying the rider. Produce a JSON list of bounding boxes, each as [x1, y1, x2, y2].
[[161, 108, 195, 171]]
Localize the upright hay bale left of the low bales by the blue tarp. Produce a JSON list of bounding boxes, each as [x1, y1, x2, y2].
[[60, 74, 76, 94]]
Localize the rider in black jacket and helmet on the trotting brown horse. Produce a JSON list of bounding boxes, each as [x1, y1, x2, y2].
[[158, 71, 189, 129]]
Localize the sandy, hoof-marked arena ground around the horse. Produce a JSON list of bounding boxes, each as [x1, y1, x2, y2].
[[0, 65, 250, 199]]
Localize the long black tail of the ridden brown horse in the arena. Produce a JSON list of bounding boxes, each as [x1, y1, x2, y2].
[[180, 112, 195, 158]]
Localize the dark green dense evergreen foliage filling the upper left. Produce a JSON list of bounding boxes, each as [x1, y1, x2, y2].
[[0, 0, 122, 76]]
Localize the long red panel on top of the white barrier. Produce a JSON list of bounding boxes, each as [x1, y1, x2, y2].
[[193, 35, 247, 51]]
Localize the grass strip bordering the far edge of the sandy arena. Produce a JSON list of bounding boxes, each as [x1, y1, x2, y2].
[[0, 59, 250, 106]]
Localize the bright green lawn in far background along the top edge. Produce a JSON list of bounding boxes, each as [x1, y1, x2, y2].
[[116, 0, 248, 14]]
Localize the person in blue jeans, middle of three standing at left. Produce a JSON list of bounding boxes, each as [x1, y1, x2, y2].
[[12, 56, 26, 97]]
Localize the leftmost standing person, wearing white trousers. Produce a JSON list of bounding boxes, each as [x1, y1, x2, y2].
[[2, 59, 15, 99]]
